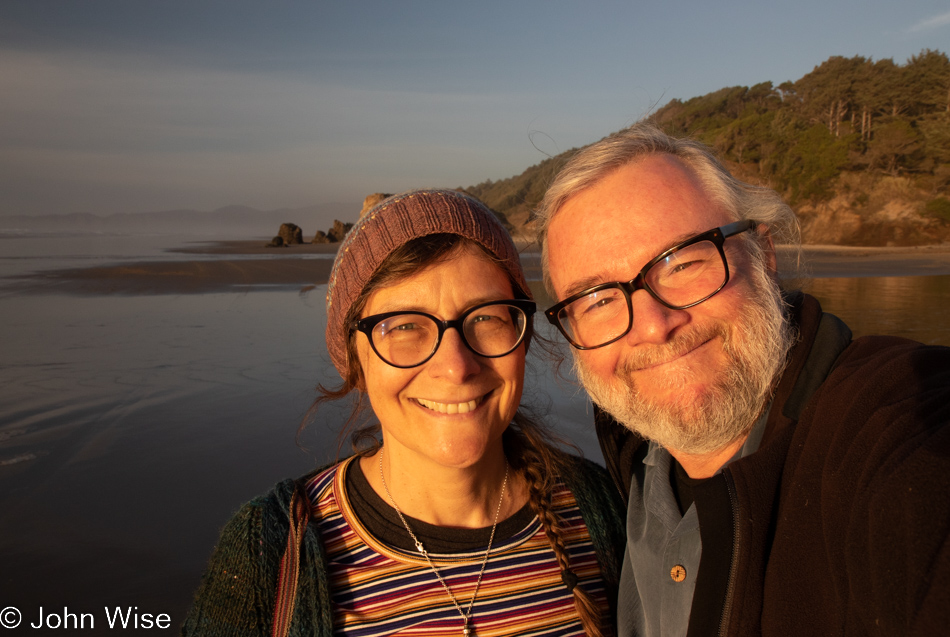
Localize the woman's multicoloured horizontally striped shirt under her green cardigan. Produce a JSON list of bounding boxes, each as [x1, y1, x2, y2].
[[307, 458, 607, 637]]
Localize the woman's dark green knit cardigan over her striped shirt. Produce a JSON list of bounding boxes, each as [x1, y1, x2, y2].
[[181, 458, 626, 637]]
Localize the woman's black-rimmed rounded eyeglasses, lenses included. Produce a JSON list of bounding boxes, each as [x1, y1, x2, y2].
[[350, 299, 537, 368]]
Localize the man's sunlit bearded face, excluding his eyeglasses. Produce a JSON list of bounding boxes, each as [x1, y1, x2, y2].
[[547, 155, 783, 453]]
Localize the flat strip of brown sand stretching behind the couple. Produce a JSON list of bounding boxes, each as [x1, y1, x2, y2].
[[4, 240, 950, 295]]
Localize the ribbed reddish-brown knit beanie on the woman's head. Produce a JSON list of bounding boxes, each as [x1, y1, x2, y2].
[[327, 190, 531, 379]]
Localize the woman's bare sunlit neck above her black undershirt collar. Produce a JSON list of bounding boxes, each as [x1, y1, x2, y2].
[[360, 447, 528, 528]]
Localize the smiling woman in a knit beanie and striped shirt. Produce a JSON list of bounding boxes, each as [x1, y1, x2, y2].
[[183, 190, 624, 636]]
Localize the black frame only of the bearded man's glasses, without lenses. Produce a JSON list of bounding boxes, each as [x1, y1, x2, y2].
[[544, 219, 759, 350]]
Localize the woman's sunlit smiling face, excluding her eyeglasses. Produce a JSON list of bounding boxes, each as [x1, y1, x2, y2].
[[356, 246, 525, 467]]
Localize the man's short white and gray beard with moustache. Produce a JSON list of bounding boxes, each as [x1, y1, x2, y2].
[[574, 266, 795, 455]]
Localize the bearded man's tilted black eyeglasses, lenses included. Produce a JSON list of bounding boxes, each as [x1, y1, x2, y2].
[[544, 219, 758, 349]]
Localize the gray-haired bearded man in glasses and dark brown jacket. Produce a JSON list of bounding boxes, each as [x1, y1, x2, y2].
[[539, 123, 950, 636]]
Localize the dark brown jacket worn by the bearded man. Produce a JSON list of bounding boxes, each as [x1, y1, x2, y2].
[[597, 295, 950, 635]]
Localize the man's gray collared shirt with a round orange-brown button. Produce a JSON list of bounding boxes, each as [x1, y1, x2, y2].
[[617, 409, 769, 637]]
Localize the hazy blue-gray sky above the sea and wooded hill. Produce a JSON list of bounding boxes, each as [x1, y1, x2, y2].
[[0, 0, 950, 215]]
